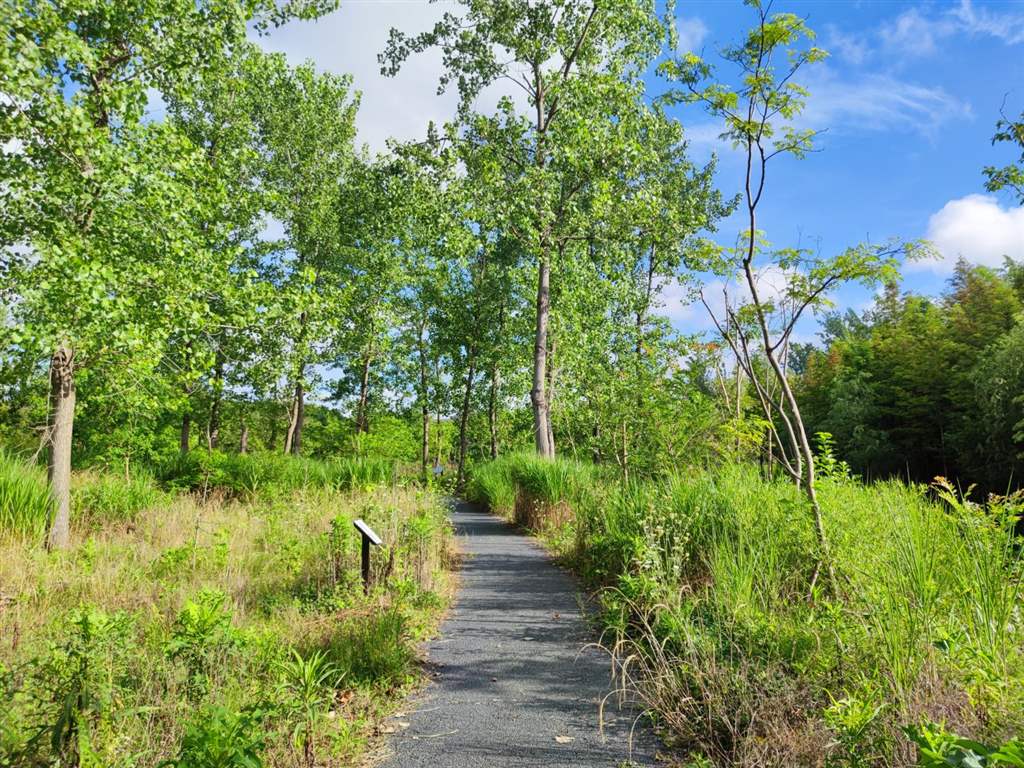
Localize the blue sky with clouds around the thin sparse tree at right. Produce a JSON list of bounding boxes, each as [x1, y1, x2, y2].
[[651, 1, 1024, 336]]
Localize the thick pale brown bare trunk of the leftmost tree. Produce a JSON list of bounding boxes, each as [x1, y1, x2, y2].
[[46, 344, 75, 550]]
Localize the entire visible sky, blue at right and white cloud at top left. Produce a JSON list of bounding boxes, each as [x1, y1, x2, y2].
[[261, 0, 1024, 348]]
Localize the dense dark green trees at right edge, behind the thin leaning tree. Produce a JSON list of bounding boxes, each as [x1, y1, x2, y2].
[[795, 259, 1024, 494]]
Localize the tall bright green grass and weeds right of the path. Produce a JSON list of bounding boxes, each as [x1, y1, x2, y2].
[[471, 456, 1024, 766]]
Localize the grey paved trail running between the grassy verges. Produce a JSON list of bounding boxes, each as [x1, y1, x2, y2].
[[384, 502, 654, 768]]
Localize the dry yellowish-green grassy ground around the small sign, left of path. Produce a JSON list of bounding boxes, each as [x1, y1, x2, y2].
[[0, 460, 451, 768]]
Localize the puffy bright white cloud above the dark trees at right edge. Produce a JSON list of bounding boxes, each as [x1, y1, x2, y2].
[[911, 195, 1024, 272]]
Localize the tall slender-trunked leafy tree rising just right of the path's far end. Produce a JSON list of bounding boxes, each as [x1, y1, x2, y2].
[[380, 0, 664, 457]]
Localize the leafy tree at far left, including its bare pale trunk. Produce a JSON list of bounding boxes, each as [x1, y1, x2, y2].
[[0, 0, 331, 547]]
